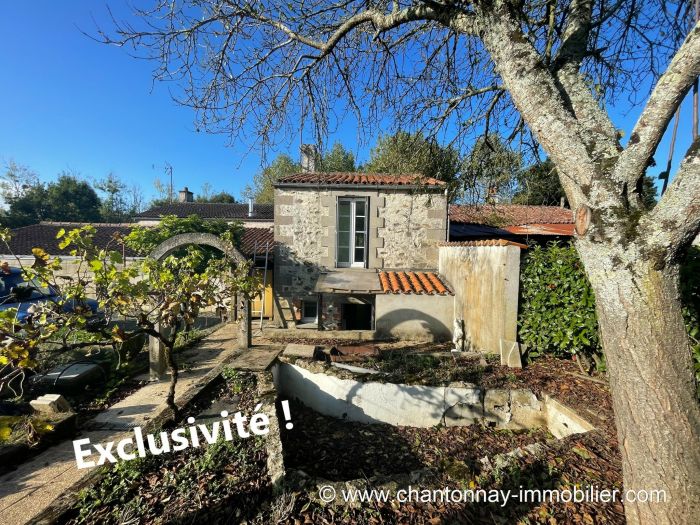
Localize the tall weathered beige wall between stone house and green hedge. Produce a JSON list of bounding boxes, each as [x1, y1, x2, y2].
[[439, 246, 520, 354]]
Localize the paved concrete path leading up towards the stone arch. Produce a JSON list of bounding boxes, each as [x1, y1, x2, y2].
[[0, 324, 237, 525]]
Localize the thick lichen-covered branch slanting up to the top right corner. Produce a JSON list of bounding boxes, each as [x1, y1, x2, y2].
[[614, 22, 700, 187]]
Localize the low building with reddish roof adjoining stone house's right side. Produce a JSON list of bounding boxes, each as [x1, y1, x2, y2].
[[450, 204, 574, 242]]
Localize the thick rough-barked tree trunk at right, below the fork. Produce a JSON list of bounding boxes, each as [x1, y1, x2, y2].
[[577, 241, 700, 524]]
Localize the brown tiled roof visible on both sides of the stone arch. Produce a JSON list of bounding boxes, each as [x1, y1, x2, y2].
[[0, 222, 274, 257]]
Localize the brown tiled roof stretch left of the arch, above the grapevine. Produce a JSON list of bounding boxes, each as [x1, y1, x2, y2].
[[0, 222, 136, 257]]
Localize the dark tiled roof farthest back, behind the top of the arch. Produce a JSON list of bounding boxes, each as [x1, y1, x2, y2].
[[136, 202, 275, 221]]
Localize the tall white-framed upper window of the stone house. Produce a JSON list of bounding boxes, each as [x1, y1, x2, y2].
[[336, 197, 368, 268]]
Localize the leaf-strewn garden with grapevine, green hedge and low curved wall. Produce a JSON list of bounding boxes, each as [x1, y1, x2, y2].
[[0, 231, 700, 525]]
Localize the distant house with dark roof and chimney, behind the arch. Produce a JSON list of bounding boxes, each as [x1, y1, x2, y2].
[[134, 187, 274, 228]]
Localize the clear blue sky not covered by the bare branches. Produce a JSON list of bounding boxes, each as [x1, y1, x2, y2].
[[0, 0, 691, 205]]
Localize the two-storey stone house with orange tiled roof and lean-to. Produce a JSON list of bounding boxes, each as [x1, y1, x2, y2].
[[274, 173, 453, 339]]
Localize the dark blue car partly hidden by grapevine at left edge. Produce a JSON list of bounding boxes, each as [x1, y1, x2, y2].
[[0, 268, 104, 326]]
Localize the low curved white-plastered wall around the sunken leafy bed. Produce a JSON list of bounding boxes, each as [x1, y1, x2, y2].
[[272, 362, 593, 438]]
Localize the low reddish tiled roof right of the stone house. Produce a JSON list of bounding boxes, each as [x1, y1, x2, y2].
[[450, 204, 574, 228]]
